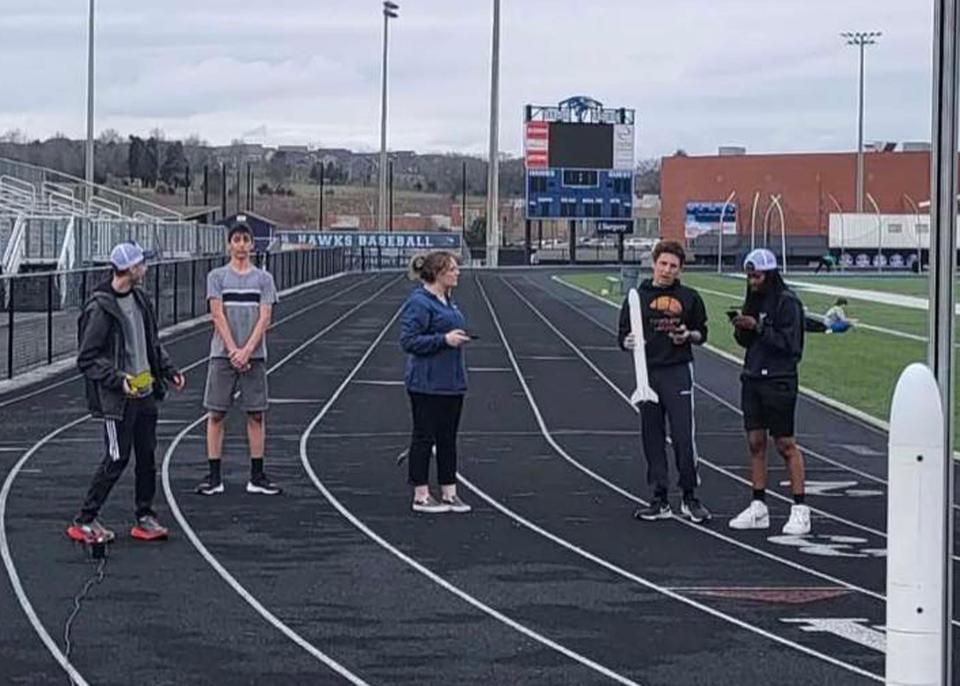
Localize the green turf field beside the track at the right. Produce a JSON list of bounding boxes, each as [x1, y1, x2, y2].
[[561, 273, 948, 421]]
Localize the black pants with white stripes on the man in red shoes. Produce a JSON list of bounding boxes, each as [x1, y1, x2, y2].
[[79, 396, 157, 522]]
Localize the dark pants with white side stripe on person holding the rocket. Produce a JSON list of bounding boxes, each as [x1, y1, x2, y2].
[[640, 364, 697, 495]]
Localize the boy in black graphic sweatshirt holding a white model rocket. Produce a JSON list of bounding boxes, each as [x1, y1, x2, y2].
[[617, 241, 710, 524]]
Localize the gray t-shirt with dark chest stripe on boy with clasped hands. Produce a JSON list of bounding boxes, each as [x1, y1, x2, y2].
[[207, 264, 278, 360]]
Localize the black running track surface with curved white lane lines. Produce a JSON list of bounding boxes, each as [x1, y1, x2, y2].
[[0, 271, 956, 685]]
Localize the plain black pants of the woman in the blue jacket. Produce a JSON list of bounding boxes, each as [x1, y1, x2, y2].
[[409, 393, 463, 486]]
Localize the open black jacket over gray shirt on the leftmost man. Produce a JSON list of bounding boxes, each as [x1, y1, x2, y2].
[[77, 280, 179, 420]]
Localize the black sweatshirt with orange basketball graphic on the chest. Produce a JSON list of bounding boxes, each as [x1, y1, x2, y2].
[[617, 279, 707, 368]]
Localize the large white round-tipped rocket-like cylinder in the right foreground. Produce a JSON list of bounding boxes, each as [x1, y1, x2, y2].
[[886, 363, 946, 686]]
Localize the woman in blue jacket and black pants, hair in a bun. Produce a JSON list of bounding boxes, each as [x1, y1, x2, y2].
[[400, 251, 470, 512]]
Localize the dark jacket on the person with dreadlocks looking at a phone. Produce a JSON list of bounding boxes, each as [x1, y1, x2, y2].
[[733, 289, 803, 379]]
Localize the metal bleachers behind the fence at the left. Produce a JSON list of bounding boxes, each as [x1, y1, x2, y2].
[[0, 158, 223, 275]]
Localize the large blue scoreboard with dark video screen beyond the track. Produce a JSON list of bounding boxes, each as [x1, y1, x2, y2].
[[524, 97, 635, 233]]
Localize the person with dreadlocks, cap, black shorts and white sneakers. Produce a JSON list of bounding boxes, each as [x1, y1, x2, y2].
[[729, 248, 810, 535]]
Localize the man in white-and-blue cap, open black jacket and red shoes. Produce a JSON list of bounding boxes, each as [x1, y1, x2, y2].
[[67, 242, 185, 543]]
